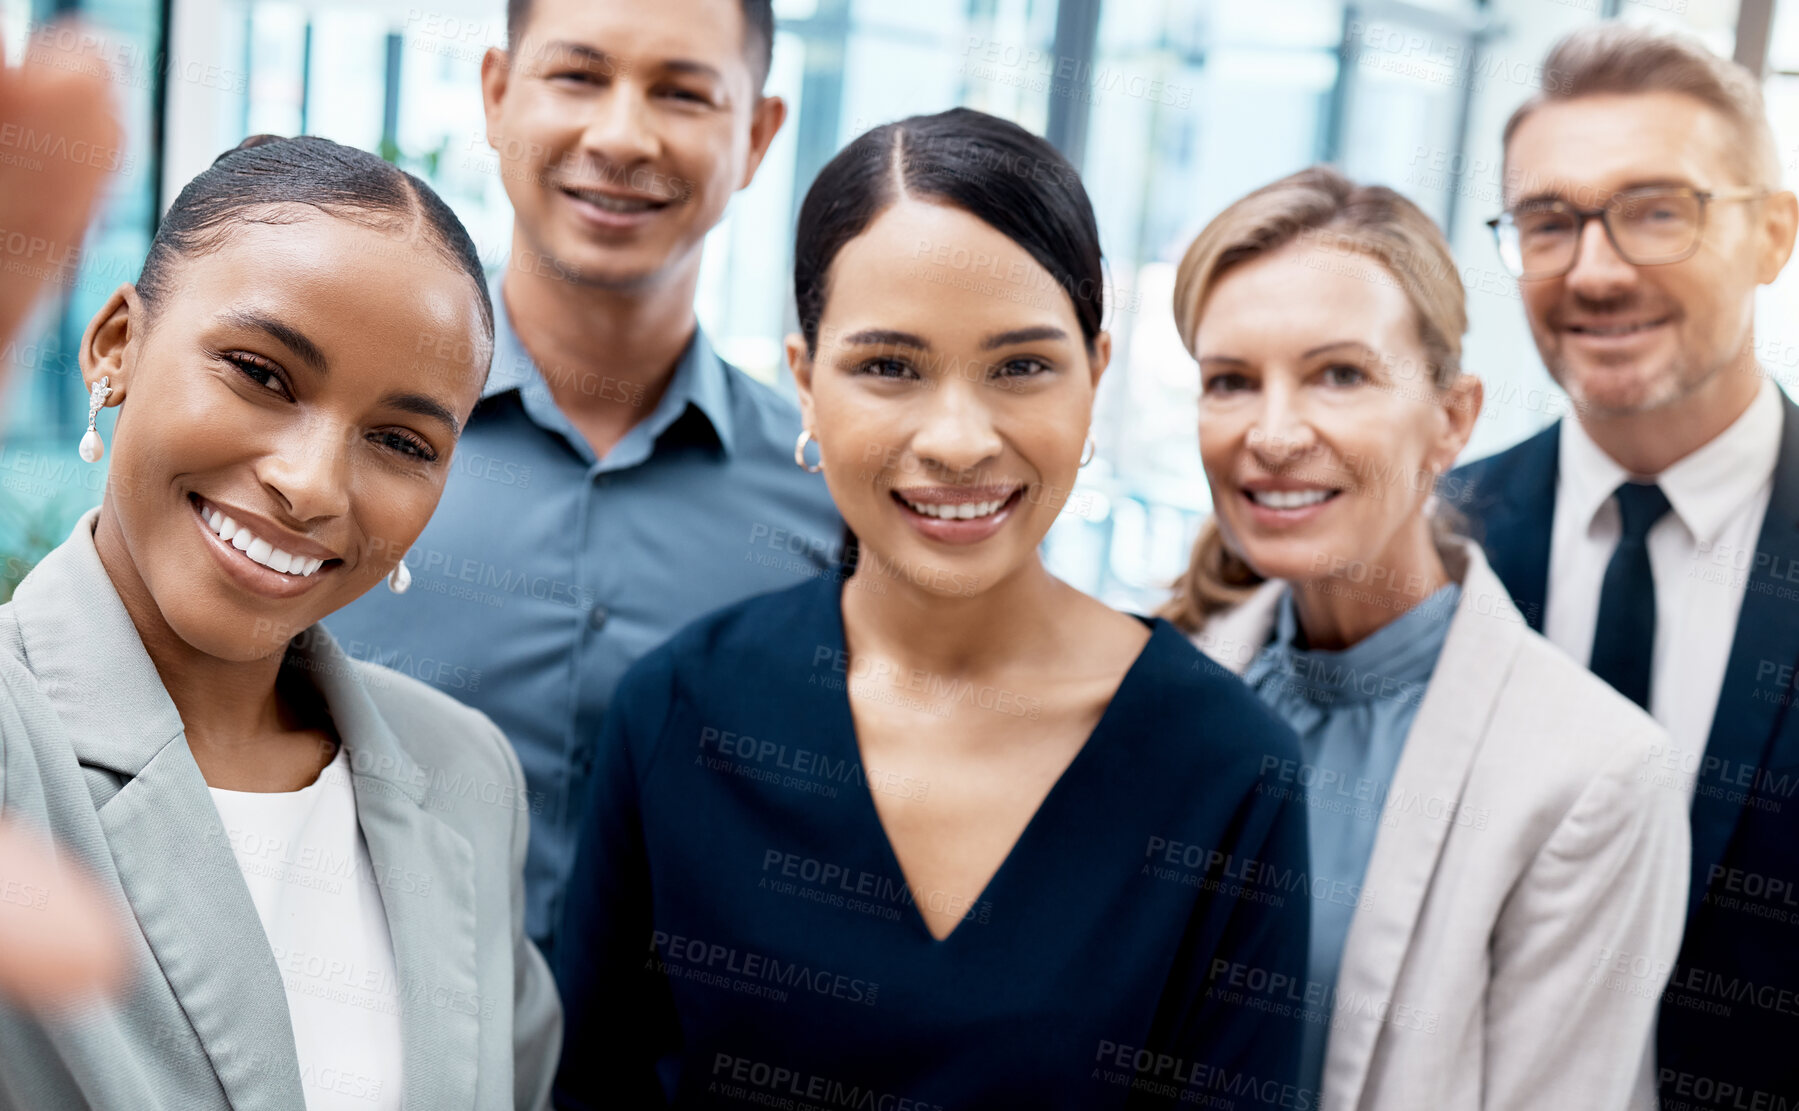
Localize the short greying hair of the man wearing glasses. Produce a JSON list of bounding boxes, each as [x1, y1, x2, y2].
[[1504, 20, 1781, 192]]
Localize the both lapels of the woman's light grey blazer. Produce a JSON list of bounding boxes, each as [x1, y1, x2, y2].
[[13, 511, 485, 1111]]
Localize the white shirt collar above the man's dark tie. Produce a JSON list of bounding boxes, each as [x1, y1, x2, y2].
[[1556, 376, 1781, 545]]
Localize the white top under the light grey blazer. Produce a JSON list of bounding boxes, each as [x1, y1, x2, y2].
[[210, 744, 401, 1111]]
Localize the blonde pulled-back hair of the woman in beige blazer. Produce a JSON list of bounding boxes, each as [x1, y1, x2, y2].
[[1160, 165, 1468, 633]]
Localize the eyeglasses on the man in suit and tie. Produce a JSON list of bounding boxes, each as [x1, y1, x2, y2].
[[1486, 185, 1768, 282]]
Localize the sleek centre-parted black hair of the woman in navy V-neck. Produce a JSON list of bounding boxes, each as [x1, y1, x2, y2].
[[793, 108, 1105, 352]]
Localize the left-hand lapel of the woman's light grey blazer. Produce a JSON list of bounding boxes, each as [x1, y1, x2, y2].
[[13, 511, 304, 1111]]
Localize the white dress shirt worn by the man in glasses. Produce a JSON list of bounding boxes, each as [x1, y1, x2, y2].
[[1544, 378, 1781, 795]]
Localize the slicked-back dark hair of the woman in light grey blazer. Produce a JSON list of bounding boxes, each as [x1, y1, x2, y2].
[[137, 135, 493, 338]]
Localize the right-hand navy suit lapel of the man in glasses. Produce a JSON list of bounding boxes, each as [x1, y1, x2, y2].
[[1687, 394, 1799, 926]]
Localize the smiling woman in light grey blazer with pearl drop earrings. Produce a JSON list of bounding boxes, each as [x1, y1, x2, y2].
[[0, 137, 561, 1111]]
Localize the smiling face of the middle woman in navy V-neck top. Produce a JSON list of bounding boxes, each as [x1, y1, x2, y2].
[[788, 200, 1110, 595]]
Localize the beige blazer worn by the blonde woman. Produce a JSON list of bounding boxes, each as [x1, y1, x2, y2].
[[1195, 541, 1689, 1111]]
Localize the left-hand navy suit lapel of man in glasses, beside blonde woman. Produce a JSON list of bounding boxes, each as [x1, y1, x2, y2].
[[1466, 422, 1562, 633]]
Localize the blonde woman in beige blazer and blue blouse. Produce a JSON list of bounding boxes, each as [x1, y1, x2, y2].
[[1164, 169, 1689, 1111]]
